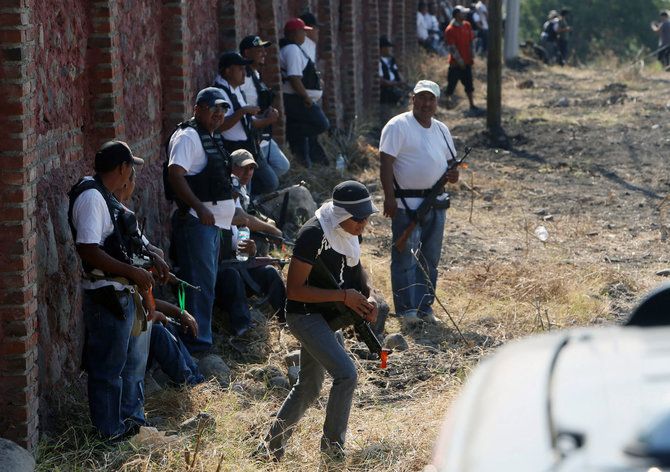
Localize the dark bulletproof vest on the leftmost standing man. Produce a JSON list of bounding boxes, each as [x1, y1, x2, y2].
[[68, 175, 142, 275]]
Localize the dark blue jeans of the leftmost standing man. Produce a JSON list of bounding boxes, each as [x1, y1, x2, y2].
[[83, 290, 147, 437]]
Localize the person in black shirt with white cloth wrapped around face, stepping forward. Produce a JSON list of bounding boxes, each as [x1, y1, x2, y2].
[[257, 181, 378, 460]]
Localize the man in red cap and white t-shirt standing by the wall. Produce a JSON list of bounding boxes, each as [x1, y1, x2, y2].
[[279, 18, 330, 167]]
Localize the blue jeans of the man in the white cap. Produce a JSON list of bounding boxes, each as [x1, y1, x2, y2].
[[391, 209, 447, 316]]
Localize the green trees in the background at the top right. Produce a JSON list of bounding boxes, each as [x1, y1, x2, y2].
[[519, 0, 670, 62]]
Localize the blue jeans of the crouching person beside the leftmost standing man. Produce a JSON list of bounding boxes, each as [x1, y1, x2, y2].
[[147, 323, 205, 385]]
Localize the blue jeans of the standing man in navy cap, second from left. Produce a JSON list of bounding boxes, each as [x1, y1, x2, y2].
[[172, 212, 219, 352]]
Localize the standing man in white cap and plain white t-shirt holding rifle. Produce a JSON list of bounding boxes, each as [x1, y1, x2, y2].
[[379, 80, 458, 326]]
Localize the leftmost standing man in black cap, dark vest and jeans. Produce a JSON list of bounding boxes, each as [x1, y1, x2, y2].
[[68, 141, 167, 438]]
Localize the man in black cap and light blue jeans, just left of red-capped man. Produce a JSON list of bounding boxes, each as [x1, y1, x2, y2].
[[240, 35, 291, 195]]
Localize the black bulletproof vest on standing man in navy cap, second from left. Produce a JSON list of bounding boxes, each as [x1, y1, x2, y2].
[[163, 119, 233, 206]]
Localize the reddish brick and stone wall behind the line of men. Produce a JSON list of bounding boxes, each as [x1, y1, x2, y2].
[[0, 0, 416, 449]]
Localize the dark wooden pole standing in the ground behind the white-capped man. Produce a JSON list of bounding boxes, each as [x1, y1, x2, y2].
[[486, 0, 510, 146]]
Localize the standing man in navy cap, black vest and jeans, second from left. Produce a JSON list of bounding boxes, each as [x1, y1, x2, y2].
[[166, 87, 235, 352]]
